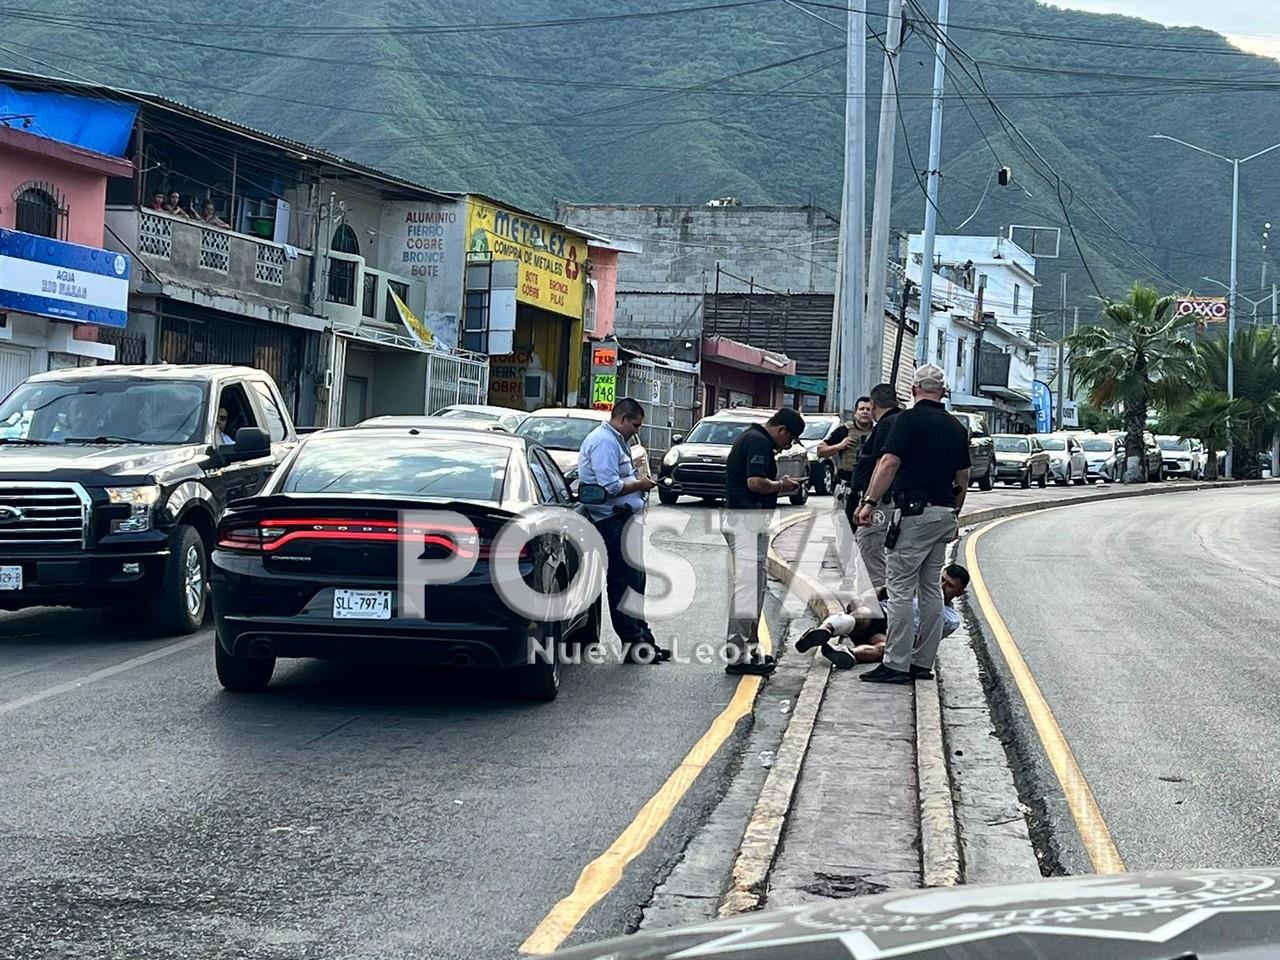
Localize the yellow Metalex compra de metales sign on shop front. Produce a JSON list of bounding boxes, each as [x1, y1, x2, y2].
[[467, 197, 586, 320]]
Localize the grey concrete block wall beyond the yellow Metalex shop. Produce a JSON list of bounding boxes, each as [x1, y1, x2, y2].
[[553, 202, 840, 293]]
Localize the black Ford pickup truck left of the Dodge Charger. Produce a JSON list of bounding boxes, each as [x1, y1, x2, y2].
[[0, 365, 297, 634]]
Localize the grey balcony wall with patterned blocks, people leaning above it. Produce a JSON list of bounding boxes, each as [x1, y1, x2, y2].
[[106, 206, 317, 314]]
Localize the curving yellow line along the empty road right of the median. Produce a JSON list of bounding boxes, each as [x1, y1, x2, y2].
[[965, 517, 1125, 873]]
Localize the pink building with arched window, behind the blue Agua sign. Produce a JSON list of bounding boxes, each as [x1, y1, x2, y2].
[[0, 122, 133, 397]]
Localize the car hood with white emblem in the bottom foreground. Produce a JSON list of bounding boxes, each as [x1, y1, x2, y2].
[[556, 869, 1280, 960]]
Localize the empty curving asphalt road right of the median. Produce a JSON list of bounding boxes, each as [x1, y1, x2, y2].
[[978, 488, 1280, 873]]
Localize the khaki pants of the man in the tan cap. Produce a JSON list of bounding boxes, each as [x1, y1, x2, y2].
[[884, 507, 959, 671]]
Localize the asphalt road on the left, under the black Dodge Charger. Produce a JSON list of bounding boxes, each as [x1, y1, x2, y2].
[[0, 504, 778, 960]]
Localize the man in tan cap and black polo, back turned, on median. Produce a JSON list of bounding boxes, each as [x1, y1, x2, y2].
[[858, 364, 969, 684]]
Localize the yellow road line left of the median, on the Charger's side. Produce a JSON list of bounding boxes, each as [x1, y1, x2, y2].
[[520, 616, 773, 954]]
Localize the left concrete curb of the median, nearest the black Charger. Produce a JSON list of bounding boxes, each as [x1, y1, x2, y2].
[[716, 511, 838, 916]]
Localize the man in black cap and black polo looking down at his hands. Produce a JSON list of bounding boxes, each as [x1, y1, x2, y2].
[[721, 407, 804, 676]]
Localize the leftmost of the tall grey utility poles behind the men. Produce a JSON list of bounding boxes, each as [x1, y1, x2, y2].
[[828, 0, 870, 413]]
